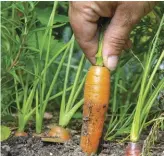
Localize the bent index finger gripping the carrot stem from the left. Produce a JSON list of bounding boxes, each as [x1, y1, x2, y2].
[[69, 2, 99, 64]]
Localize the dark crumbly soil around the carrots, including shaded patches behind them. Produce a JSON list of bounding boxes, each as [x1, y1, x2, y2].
[[1, 114, 164, 156]]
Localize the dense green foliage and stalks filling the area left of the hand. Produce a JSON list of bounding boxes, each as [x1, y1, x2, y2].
[[1, 2, 88, 133]]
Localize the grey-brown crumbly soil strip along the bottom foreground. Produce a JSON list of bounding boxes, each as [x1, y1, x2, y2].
[[1, 131, 164, 156]]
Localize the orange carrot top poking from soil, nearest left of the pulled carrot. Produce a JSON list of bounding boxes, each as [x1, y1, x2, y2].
[[48, 126, 71, 142]]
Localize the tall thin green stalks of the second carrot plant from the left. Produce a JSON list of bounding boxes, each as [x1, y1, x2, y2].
[[35, 1, 73, 134]]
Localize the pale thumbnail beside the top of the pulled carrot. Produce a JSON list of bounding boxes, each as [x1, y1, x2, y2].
[[104, 55, 118, 71]]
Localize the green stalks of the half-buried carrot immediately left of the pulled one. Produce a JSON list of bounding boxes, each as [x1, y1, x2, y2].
[[59, 37, 85, 127]]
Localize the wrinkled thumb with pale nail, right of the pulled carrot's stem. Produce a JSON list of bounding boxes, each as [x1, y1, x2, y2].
[[103, 7, 134, 70]]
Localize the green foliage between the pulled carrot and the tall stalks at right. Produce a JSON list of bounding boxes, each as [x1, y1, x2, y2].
[[105, 64, 136, 140]]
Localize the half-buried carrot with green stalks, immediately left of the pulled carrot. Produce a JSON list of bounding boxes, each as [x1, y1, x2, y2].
[[42, 36, 85, 142]]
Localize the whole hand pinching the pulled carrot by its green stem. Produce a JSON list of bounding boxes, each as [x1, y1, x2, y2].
[[69, 1, 156, 70]]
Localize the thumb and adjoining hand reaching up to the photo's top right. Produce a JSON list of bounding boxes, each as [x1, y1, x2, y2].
[[103, 2, 156, 70]]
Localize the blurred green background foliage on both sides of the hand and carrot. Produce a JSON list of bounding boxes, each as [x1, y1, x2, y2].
[[1, 2, 164, 153]]
